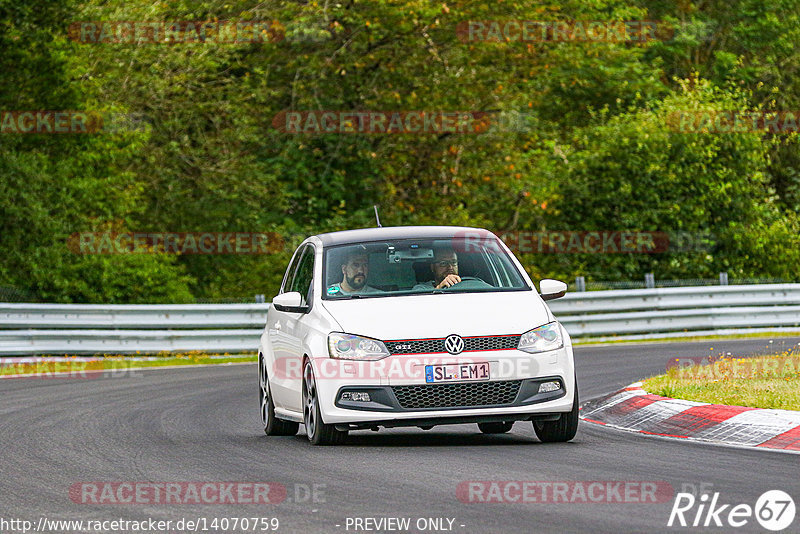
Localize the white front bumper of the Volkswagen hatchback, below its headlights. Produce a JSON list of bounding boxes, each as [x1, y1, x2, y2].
[[313, 345, 575, 428]]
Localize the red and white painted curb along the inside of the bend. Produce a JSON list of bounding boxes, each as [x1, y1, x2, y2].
[[580, 382, 800, 452]]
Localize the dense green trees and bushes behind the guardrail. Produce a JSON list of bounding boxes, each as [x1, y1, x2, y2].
[[0, 0, 800, 302]]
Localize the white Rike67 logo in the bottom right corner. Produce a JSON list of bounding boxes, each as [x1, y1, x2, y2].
[[667, 490, 795, 532]]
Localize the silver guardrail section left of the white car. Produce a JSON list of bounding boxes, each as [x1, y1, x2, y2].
[[0, 303, 269, 356]]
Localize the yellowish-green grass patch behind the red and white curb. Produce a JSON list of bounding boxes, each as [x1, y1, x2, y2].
[[642, 351, 800, 410]]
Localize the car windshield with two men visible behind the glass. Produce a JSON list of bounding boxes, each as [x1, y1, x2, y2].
[[323, 237, 530, 300]]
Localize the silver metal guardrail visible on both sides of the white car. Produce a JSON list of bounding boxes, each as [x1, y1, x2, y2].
[[0, 284, 800, 356]]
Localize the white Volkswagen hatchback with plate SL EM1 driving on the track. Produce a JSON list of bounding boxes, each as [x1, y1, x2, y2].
[[258, 226, 578, 445]]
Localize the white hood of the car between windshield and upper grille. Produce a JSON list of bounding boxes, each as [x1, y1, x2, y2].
[[322, 290, 553, 340]]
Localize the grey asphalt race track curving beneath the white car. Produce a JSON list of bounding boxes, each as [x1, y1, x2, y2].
[[0, 338, 800, 533]]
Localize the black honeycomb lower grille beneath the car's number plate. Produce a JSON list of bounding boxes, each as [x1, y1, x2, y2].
[[392, 380, 522, 410]]
